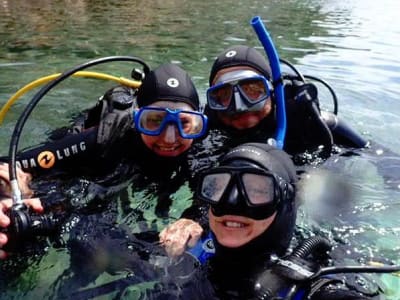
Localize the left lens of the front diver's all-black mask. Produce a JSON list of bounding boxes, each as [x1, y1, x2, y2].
[[200, 173, 232, 203]]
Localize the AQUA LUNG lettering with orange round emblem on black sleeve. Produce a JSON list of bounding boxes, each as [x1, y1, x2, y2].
[[18, 142, 86, 169]]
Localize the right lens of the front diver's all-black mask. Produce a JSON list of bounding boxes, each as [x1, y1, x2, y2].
[[241, 173, 275, 205]]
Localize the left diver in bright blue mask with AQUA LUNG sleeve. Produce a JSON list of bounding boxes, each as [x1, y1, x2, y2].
[[0, 63, 207, 260]]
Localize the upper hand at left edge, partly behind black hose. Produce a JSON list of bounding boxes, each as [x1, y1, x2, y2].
[[0, 163, 33, 198]]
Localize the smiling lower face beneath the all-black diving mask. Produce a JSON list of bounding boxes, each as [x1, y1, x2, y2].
[[208, 209, 276, 248]]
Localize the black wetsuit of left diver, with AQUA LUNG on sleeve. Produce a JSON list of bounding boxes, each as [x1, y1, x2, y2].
[[7, 87, 203, 205]]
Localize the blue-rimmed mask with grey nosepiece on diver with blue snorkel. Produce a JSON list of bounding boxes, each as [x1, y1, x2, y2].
[[207, 70, 273, 113]]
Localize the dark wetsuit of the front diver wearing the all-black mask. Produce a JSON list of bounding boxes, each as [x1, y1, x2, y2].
[[87, 232, 385, 300]]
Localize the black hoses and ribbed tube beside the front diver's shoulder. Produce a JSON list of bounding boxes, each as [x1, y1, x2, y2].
[[254, 236, 400, 300]]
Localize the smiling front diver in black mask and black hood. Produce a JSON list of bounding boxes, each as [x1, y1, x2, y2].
[[72, 143, 390, 300]]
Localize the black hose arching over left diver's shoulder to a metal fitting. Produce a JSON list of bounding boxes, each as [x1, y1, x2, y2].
[[8, 56, 150, 209]]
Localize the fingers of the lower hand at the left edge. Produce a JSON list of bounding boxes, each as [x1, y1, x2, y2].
[[0, 198, 43, 260]]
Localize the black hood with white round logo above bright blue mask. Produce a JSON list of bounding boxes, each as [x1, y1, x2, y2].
[[137, 63, 200, 111]]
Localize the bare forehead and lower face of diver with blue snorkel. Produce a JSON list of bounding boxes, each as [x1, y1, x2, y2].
[[213, 66, 272, 130]]
